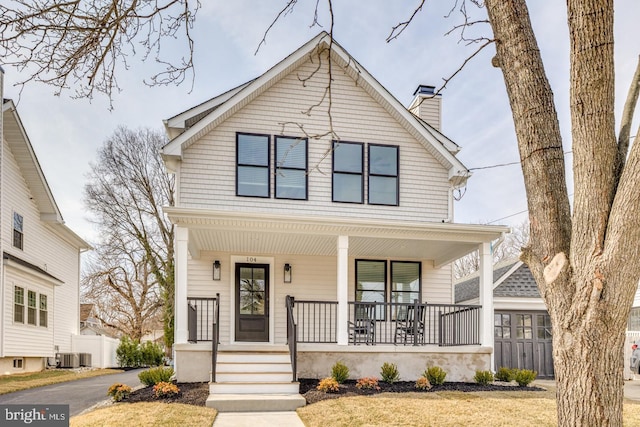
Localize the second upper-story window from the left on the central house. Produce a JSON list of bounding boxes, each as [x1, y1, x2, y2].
[[275, 136, 308, 200]]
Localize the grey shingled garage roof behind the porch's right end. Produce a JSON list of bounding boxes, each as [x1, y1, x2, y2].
[[455, 260, 540, 303]]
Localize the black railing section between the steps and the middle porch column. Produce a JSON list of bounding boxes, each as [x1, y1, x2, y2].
[[292, 297, 338, 343]]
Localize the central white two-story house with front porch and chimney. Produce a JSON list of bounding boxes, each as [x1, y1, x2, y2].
[[163, 33, 509, 409]]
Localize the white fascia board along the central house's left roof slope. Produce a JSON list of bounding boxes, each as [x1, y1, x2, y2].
[[162, 32, 329, 157]]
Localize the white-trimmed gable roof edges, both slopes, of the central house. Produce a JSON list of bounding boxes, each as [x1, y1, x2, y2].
[[162, 31, 470, 187]]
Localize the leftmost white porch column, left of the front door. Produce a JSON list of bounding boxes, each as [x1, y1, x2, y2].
[[174, 226, 189, 344]]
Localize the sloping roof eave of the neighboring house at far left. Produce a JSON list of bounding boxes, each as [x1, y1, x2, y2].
[[2, 99, 91, 249]]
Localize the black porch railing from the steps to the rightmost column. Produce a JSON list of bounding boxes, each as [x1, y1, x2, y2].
[[292, 300, 481, 346]]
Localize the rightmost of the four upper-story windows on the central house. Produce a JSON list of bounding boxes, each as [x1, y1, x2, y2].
[[369, 144, 399, 206]]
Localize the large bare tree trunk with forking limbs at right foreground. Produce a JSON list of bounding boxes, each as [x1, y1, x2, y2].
[[486, 0, 640, 426]]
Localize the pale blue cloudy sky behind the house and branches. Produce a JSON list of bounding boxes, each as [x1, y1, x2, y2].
[[3, 0, 640, 242]]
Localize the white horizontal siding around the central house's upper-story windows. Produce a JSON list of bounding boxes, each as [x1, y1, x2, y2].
[[178, 53, 450, 222]]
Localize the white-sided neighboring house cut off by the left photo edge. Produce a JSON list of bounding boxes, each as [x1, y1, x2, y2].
[[0, 69, 89, 374]]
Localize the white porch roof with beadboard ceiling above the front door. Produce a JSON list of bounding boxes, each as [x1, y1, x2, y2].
[[165, 207, 509, 266]]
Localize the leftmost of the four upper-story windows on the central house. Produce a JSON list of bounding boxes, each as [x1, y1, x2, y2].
[[236, 133, 270, 197]]
